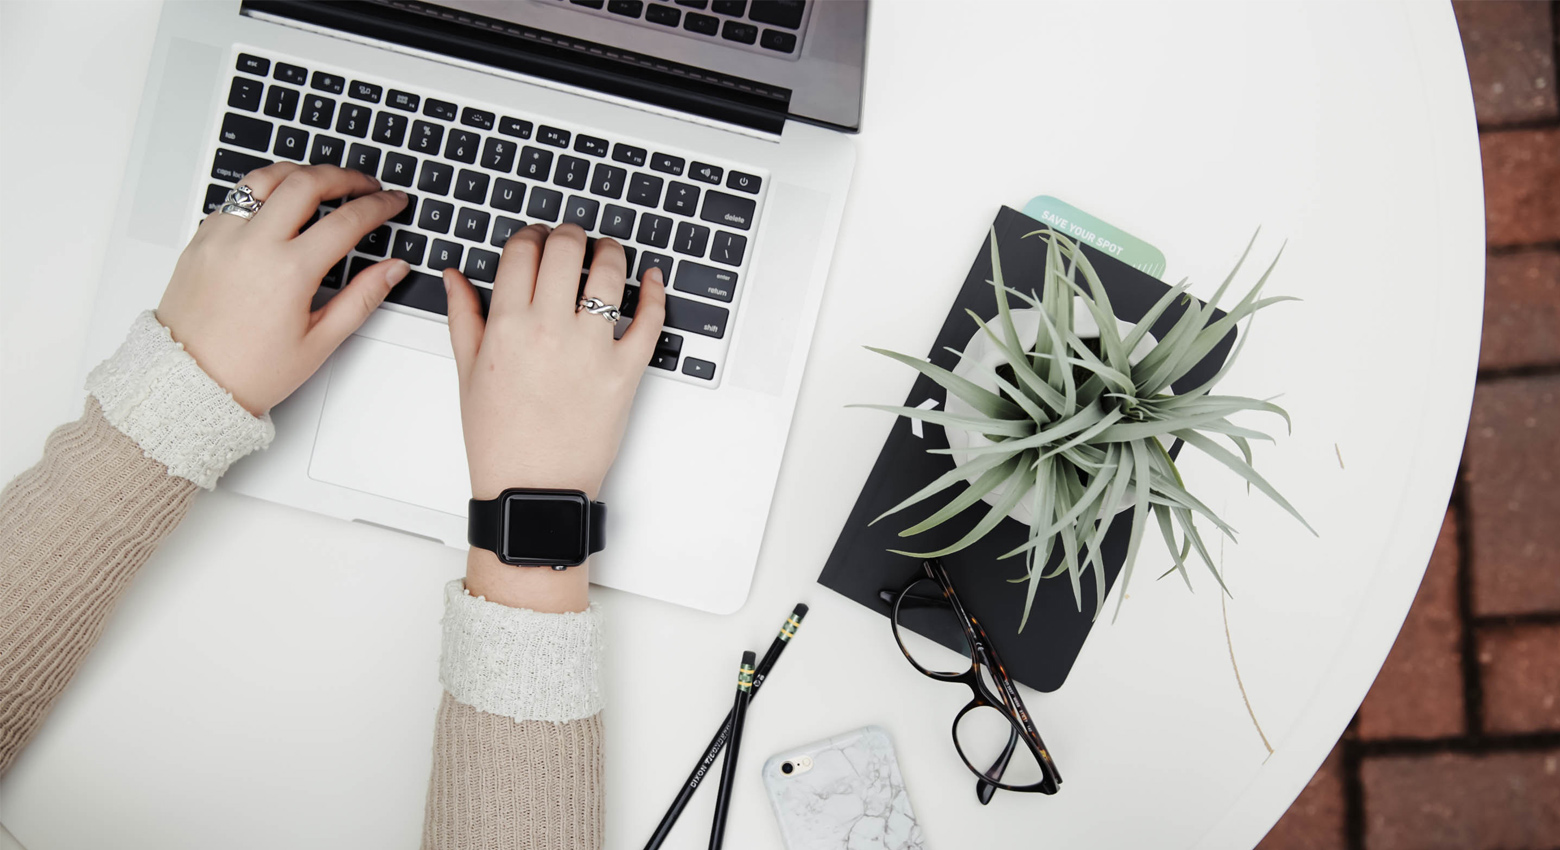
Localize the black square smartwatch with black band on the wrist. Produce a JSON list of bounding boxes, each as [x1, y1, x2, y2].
[[466, 488, 607, 569]]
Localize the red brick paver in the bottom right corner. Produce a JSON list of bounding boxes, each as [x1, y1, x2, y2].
[[1360, 749, 1560, 850]]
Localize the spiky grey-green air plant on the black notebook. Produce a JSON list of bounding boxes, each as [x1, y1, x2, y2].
[[863, 228, 1315, 630]]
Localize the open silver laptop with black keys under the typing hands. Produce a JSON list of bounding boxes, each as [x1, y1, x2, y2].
[[86, 0, 866, 613]]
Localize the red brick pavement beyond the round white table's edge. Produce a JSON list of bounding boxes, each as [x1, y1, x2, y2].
[[1259, 0, 1560, 850]]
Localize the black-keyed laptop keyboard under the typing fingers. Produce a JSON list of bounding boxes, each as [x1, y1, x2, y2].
[[204, 50, 768, 387]]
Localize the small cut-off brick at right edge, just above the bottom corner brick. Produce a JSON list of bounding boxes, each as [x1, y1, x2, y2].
[[1479, 622, 1560, 733]]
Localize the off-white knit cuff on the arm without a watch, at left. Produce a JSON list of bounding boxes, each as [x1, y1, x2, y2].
[[87, 310, 276, 490]]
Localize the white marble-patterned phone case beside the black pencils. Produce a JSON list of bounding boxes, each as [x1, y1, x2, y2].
[[764, 725, 925, 850]]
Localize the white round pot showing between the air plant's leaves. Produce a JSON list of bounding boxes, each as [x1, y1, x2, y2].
[[944, 296, 1154, 526]]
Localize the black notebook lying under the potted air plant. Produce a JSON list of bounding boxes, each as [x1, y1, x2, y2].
[[817, 207, 1236, 691]]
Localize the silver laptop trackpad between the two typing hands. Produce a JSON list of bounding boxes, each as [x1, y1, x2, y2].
[[309, 335, 471, 516]]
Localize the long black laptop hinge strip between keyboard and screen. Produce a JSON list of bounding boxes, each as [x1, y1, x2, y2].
[[242, 0, 791, 136]]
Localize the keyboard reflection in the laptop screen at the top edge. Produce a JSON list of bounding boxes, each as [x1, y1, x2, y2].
[[566, 0, 810, 59]]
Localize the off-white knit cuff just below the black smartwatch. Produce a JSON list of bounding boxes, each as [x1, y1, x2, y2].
[[438, 579, 607, 724]]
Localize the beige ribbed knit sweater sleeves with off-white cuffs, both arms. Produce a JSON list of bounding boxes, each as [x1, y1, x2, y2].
[[0, 313, 602, 850]]
